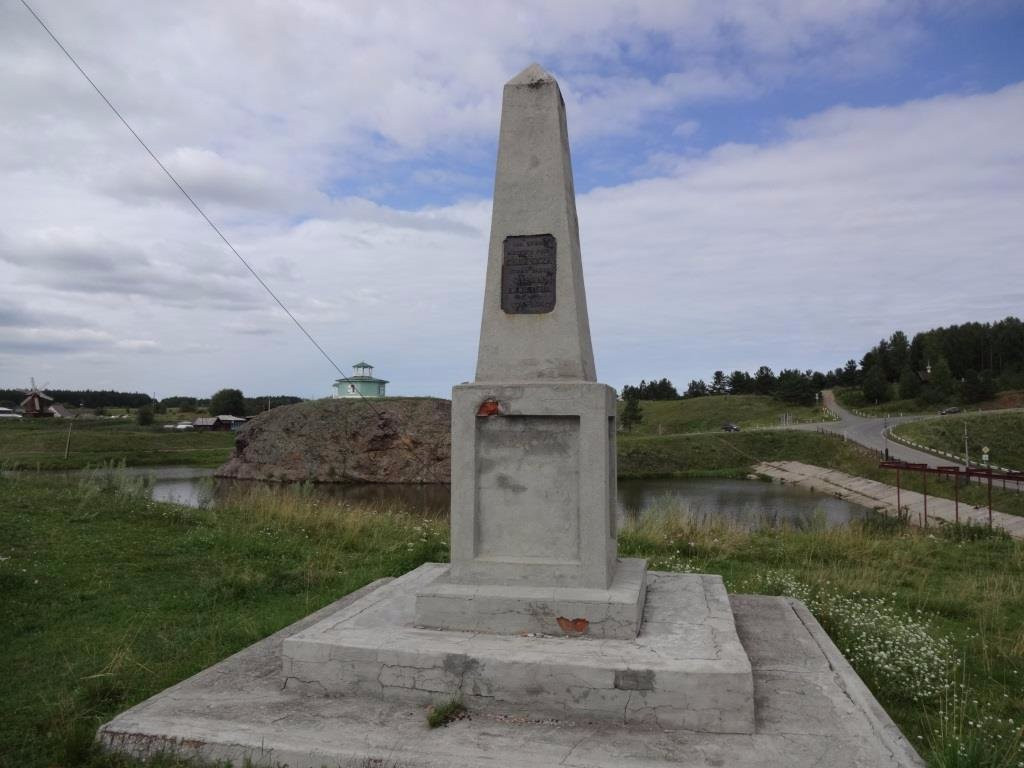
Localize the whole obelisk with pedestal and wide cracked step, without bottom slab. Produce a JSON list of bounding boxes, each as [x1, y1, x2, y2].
[[282, 65, 754, 733]]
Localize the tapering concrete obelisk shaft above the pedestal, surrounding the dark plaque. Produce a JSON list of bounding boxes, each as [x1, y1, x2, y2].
[[476, 63, 597, 382]]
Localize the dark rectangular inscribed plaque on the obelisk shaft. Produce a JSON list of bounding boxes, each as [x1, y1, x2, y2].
[[502, 234, 557, 314]]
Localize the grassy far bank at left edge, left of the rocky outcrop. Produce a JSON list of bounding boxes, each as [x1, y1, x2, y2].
[[0, 419, 234, 469]]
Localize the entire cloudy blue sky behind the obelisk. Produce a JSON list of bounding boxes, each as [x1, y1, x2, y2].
[[0, 0, 1024, 397]]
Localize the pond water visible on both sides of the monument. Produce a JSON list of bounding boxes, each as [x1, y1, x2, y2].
[[129, 467, 866, 527]]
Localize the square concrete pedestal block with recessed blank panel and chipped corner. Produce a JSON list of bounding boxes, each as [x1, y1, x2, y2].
[[451, 381, 615, 590]]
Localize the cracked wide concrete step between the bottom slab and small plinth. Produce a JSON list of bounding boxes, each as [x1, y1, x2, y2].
[[283, 563, 754, 733]]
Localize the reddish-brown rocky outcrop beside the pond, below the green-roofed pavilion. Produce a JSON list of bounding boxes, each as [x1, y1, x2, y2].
[[216, 397, 452, 482]]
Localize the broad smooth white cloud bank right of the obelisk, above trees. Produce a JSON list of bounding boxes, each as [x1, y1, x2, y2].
[[581, 84, 1024, 379]]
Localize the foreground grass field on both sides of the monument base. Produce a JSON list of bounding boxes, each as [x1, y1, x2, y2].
[[0, 474, 1024, 768]]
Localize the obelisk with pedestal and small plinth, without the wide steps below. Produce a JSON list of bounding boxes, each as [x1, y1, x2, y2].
[[417, 65, 646, 638]]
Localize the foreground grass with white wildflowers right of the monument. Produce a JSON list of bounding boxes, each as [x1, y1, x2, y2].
[[618, 510, 1024, 768]]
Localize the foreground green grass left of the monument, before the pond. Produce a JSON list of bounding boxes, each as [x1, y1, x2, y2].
[[0, 475, 447, 767]]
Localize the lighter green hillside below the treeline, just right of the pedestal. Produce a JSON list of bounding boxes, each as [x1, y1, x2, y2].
[[618, 394, 825, 435]]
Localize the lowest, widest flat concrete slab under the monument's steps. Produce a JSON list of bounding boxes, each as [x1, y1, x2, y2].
[[98, 585, 923, 768]]
